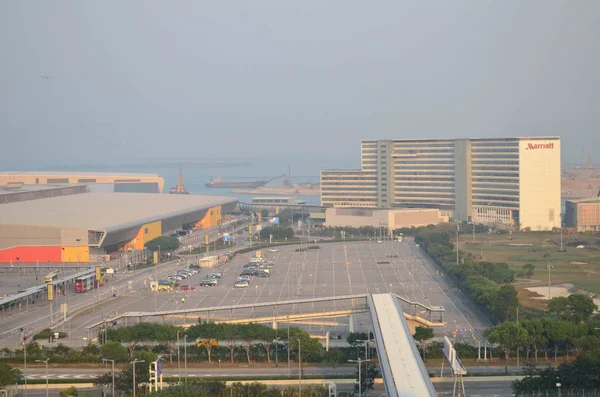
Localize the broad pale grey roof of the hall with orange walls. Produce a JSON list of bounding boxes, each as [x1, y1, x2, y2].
[[0, 193, 237, 231]]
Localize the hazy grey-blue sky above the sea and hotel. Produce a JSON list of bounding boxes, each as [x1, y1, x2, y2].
[[0, 0, 600, 169]]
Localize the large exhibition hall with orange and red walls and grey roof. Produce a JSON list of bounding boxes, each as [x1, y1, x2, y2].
[[0, 185, 237, 264]]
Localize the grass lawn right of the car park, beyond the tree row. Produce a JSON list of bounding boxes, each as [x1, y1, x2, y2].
[[459, 232, 600, 308]]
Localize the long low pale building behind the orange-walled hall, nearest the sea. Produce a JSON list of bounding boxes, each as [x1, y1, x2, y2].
[[0, 171, 165, 193]]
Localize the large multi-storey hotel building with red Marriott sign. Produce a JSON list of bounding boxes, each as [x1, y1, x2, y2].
[[321, 137, 561, 230]]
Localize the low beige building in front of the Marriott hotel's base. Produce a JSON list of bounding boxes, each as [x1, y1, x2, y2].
[[324, 208, 448, 229]]
